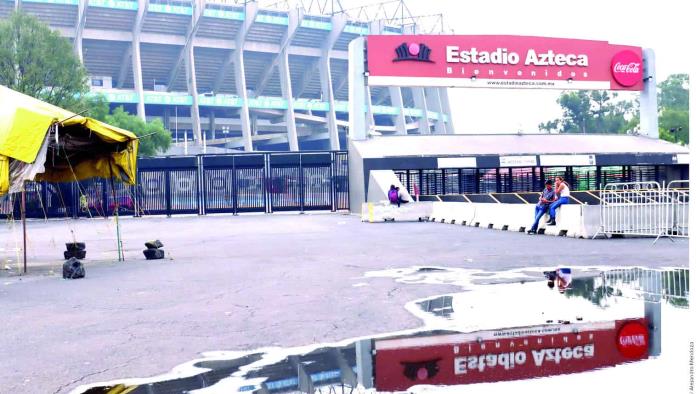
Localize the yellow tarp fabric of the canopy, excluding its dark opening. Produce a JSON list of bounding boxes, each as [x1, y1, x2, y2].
[[0, 86, 138, 195]]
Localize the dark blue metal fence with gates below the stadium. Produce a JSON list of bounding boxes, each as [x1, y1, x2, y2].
[[0, 151, 350, 218]]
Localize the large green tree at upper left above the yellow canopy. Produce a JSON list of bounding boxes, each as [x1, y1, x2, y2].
[[0, 12, 88, 110]]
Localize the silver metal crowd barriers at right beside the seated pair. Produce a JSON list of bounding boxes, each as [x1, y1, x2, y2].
[[593, 181, 689, 241]]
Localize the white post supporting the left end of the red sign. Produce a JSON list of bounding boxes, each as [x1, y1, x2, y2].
[[348, 38, 369, 142]]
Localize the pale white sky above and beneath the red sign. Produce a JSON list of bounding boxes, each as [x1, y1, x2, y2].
[[341, 0, 696, 133]]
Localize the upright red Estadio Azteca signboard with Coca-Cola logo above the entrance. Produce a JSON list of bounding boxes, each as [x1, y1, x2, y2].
[[367, 35, 643, 90]]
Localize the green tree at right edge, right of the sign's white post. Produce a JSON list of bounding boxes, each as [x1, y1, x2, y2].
[[657, 74, 689, 144]]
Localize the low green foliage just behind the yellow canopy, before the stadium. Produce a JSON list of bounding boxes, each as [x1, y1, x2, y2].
[[84, 95, 172, 156]]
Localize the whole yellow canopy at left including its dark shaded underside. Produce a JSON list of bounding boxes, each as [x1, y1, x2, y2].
[[0, 86, 138, 195]]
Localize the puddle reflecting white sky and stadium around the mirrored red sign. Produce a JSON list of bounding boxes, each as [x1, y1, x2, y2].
[[74, 267, 689, 394]]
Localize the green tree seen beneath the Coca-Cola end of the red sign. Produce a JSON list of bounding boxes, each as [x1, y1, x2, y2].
[[539, 90, 638, 133]]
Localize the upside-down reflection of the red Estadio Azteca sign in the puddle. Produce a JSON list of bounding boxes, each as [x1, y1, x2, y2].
[[375, 318, 648, 391]]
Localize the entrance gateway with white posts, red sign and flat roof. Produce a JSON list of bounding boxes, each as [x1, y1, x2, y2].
[[348, 35, 668, 212]]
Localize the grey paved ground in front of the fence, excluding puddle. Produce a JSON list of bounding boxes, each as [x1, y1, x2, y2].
[[0, 214, 688, 393]]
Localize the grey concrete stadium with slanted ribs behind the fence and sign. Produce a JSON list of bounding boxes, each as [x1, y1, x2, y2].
[[0, 0, 453, 153]]
